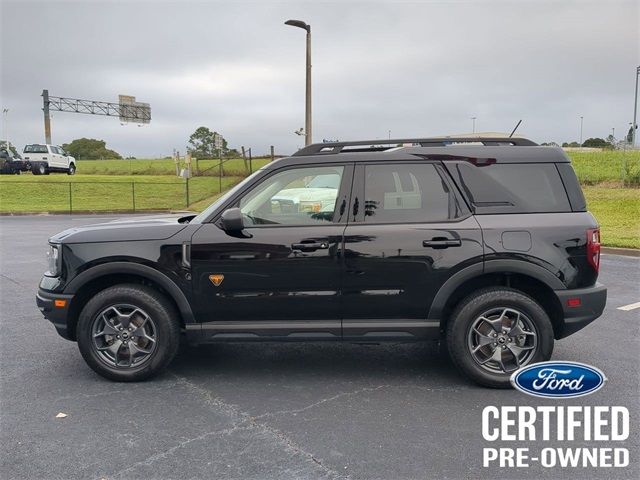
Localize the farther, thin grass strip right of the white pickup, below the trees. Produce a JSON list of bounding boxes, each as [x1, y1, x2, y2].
[[77, 158, 269, 177]]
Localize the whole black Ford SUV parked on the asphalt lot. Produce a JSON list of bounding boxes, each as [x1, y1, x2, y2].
[[37, 137, 606, 387]]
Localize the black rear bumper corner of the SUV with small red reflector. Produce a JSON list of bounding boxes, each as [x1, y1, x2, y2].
[[555, 283, 607, 338]]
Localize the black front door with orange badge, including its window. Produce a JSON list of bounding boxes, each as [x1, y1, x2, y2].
[[191, 164, 353, 340]]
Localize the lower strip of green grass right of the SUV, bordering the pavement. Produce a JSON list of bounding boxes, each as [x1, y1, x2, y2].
[[583, 186, 640, 248]]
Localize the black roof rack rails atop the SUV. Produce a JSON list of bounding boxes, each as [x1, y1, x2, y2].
[[293, 136, 537, 157]]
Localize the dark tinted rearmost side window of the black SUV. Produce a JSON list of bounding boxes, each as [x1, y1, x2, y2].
[[445, 162, 571, 214]]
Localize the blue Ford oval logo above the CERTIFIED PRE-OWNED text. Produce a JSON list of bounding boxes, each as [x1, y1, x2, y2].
[[511, 362, 606, 398]]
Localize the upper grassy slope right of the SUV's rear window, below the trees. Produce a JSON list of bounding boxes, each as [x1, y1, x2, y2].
[[568, 150, 640, 186]]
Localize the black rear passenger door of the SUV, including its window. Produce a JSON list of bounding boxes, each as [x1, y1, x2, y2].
[[342, 161, 483, 338]]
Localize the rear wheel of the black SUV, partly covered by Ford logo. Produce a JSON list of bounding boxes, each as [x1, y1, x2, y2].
[[446, 287, 553, 388]]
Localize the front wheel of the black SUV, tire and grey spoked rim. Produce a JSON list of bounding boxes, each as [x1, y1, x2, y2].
[[76, 284, 180, 382]]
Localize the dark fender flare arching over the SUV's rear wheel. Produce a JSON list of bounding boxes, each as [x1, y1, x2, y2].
[[427, 260, 567, 320]]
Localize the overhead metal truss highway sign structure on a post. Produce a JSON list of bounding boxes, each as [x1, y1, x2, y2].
[[42, 90, 151, 144]]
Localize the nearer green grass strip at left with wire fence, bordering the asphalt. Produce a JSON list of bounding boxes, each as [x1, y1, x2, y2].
[[0, 174, 242, 212]]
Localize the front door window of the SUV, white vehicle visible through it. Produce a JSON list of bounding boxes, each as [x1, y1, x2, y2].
[[239, 166, 344, 226]]
